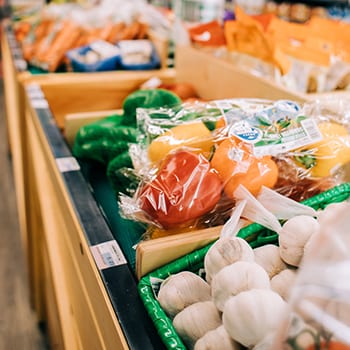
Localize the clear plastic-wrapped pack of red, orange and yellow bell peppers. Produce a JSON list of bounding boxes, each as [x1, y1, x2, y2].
[[120, 99, 350, 229]]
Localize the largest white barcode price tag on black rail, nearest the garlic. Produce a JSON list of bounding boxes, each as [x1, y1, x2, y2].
[[90, 240, 127, 270]]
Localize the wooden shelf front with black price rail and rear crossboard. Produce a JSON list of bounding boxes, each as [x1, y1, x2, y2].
[[1, 19, 174, 349]]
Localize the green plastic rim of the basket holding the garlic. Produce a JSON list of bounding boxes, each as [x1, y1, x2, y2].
[[138, 183, 350, 350]]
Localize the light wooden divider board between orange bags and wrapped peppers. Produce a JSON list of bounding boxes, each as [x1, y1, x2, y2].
[[175, 46, 350, 102]]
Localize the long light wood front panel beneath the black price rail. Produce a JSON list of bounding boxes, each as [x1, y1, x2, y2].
[[27, 91, 128, 349]]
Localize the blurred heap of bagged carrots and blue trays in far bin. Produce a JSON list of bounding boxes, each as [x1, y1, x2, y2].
[[11, 0, 170, 72]]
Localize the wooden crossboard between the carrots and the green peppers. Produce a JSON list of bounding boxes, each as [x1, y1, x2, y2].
[[21, 69, 175, 130]]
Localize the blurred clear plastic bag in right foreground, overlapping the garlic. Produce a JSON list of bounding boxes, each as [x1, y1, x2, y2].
[[269, 201, 350, 350]]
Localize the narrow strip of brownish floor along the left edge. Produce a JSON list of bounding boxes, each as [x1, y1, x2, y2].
[[0, 78, 48, 350]]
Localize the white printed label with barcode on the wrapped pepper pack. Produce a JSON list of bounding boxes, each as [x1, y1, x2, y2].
[[217, 99, 322, 157]]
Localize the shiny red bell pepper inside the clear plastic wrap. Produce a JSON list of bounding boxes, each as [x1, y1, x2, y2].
[[138, 150, 222, 229]]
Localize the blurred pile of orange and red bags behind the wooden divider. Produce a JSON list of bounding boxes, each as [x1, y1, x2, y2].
[[178, 7, 350, 93]]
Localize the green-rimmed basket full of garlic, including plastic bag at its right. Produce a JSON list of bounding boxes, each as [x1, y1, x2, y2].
[[139, 183, 350, 349]]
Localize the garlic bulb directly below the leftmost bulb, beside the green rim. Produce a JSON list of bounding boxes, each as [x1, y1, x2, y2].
[[173, 301, 222, 349]]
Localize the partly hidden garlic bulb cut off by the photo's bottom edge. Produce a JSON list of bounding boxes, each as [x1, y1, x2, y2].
[[194, 325, 242, 350]]
